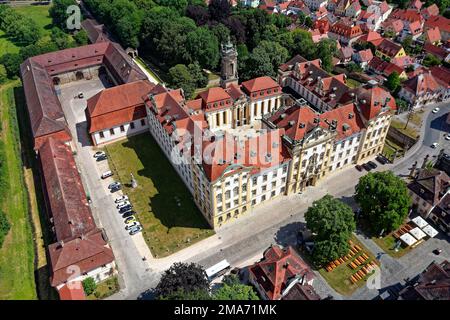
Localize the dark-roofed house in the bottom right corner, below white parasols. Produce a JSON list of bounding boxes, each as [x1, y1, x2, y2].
[[399, 260, 450, 301]]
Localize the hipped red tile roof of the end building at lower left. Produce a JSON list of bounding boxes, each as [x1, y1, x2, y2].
[[48, 230, 114, 287]]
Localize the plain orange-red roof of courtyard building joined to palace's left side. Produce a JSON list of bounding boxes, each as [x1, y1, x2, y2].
[[86, 80, 155, 133]]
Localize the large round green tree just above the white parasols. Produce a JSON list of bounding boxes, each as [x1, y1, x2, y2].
[[355, 171, 411, 234]]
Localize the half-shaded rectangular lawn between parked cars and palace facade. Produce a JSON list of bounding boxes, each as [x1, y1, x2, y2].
[[105, 133, 214, 258]]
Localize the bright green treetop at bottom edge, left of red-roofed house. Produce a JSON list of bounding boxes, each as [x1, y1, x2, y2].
[[213, 275, 259, 300]]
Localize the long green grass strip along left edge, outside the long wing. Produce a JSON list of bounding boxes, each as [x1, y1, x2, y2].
[[0, 81, 37, 300]]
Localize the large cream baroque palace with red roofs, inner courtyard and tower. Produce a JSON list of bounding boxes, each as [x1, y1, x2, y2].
[[22, 40, 396, 228]]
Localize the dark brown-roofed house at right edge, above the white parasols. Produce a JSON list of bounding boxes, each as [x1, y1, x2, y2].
[[408, 169, 450, 219]]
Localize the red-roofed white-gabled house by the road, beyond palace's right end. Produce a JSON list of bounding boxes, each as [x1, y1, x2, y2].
[[398, 71, 442, 107]]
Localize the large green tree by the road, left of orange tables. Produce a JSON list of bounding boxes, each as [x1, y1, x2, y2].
[[305, 195, 356, 264]]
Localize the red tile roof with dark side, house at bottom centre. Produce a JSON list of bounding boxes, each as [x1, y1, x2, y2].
[[249, 246, 314, 300]]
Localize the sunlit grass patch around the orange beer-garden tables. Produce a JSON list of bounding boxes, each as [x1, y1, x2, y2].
[[319, 236, 377, 296]]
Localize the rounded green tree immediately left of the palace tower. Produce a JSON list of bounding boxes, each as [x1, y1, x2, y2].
[[186, 27, 219, 69]]
